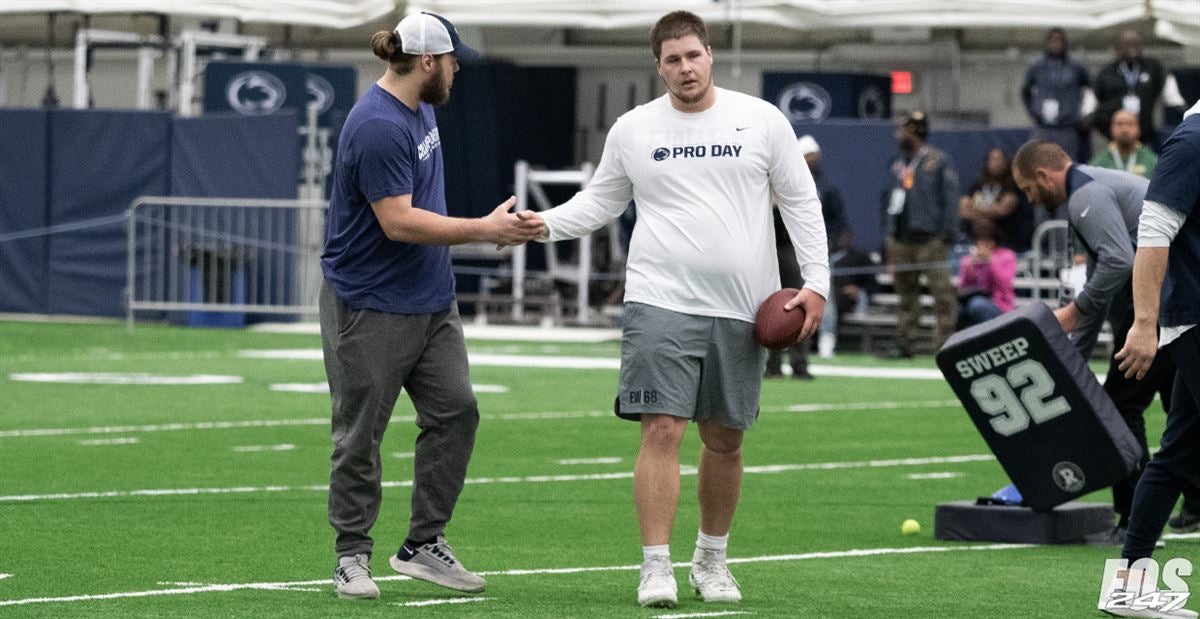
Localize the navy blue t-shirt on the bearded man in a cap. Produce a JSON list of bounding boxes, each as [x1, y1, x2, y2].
[[320, 84, 455, 314]]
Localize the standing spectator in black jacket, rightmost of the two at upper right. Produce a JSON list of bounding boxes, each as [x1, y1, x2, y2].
[[1099, 28, 1186, 149]]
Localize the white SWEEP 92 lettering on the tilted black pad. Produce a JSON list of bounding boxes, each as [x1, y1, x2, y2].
[[955, 337, 1070, 437]]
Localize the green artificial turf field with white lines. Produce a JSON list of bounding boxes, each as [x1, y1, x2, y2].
[[0, 323, 1200, 618]]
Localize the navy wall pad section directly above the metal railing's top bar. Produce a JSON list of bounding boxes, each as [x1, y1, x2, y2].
[[170, 113, 300, 199]]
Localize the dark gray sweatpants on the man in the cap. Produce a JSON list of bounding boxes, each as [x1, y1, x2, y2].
[[320, 283, 479, 557]]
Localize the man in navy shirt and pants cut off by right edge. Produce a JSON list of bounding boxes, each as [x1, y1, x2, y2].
[[1099, 103, 1200, 617]]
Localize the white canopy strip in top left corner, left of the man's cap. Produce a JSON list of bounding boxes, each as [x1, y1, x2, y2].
[[0, 0, 396, 29]]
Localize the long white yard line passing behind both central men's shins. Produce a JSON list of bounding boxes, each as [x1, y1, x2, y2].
[[0, 453, 996, 503]]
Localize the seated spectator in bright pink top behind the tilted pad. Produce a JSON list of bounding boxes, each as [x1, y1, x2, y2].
[[958, 218, 1016, 329]]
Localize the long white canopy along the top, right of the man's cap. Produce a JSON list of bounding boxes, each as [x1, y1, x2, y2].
[[407, 0, 1200, 46]]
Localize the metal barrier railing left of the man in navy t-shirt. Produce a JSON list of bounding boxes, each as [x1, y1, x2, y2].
[[125, 196, 328, 330]]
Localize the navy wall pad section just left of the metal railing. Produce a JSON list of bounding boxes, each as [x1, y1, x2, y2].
[[48, 110, 170, 315]]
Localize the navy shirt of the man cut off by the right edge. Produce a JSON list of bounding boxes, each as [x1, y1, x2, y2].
[[1146, 114, 1200, 326]]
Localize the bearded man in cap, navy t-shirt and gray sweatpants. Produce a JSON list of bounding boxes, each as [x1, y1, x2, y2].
[[320, 13, 545, 599]]
